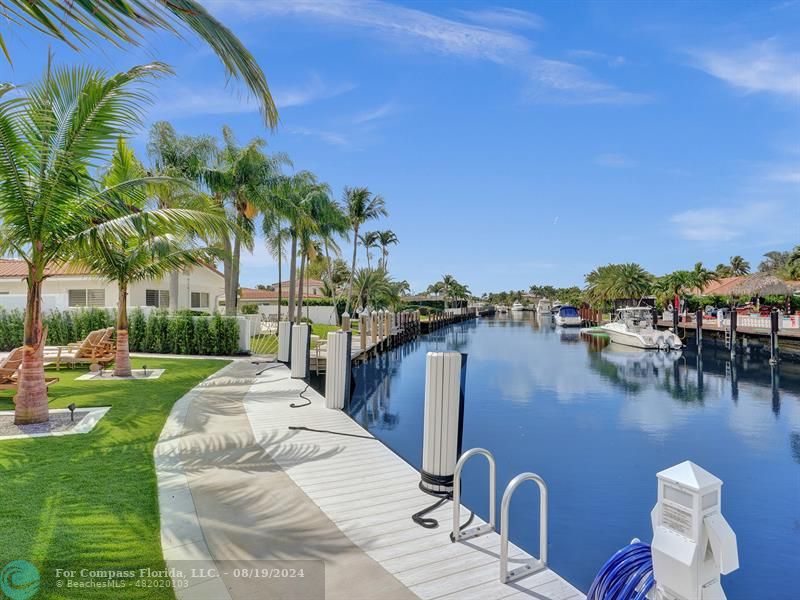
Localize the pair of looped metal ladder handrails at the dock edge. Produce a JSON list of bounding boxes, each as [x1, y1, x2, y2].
[[450, 448, 548, 583]]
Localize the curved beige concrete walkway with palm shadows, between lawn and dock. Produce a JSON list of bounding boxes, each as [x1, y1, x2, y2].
[[154, 360, 417, 600]]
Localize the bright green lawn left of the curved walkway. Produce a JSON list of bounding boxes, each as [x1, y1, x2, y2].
[[0, 358, 228, 599]]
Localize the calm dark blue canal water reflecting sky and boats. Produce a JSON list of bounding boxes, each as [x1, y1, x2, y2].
[[350, 313, 800, 600]]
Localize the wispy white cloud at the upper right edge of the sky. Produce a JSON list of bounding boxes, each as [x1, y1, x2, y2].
[[690, 39, 800, 98]]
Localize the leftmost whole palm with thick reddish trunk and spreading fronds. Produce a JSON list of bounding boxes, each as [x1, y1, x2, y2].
[[0, 63, 174, 424]]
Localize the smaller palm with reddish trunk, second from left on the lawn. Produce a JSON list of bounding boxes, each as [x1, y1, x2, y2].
[[75, 138, 228, 377]]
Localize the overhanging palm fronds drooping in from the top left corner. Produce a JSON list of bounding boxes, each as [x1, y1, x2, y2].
[[0, 0, 278, 128]]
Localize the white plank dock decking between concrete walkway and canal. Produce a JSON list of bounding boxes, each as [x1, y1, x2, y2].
[[243, 366, 585, 600]]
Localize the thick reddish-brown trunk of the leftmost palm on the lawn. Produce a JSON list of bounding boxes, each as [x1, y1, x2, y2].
[[14, 265, 49, 425]]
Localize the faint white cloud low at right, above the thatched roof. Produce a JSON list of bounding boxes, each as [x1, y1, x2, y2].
[[670, 202, 788, 242]]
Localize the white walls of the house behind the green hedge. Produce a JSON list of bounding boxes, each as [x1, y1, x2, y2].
[[0, 258, 225, 312]]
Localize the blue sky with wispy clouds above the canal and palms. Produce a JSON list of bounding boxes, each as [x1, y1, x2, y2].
[[0, 0, 800, 293]]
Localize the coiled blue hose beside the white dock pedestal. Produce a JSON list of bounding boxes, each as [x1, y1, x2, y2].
[[586, 542, 656, 600]]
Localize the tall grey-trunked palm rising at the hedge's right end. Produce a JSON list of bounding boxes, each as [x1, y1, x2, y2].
[[203, 126, 289, 315]]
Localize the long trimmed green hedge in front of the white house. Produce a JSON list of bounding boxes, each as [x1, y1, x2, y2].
[[0, 308, 239, 356]]
